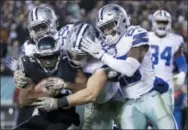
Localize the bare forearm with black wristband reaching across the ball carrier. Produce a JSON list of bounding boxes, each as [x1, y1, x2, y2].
[[57, 70, 107, 107]]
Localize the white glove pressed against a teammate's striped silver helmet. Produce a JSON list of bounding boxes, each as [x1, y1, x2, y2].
[[81, 37, 105, 59]]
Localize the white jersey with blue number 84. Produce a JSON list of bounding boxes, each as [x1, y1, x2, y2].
[[149, 32, 184, 82]]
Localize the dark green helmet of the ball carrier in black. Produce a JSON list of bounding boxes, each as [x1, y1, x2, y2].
[[33, 36, 62, 73]]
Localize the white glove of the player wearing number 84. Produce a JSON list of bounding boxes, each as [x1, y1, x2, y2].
[[174, 72, 186, 86]]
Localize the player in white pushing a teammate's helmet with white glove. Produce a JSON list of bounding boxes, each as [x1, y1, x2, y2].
[[81, 4, 178, 129]]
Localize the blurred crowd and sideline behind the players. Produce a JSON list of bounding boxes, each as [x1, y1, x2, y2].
[[0, 0, 188, 129]]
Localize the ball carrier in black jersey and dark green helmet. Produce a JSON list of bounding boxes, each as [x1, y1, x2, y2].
[[15, 36, 86, 130]]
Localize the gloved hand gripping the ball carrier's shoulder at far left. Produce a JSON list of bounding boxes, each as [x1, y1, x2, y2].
[[14, 70, 30, 88]]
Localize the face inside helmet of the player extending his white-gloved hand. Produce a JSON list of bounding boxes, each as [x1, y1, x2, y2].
[[100, 21, 117, 36]]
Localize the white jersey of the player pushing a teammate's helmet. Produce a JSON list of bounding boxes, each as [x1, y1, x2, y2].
[[103, 26, 155, 98]]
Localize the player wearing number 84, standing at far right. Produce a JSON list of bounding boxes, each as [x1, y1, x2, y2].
[[149, 10, 187, 111]]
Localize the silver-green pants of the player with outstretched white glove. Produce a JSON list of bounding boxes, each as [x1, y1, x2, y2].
[[120, 91, 176, 129]]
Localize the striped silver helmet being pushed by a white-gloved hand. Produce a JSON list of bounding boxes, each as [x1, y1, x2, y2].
[[66, 23, 96, 67]]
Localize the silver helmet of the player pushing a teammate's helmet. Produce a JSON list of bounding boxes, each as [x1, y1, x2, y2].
[[96, 4, 130, 44]]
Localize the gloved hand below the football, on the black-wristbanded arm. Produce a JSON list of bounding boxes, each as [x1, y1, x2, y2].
[[31, 97, 58, 112]]
